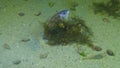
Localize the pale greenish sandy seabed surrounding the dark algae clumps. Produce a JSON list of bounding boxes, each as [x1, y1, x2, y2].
[[0, 0, 120, 68]]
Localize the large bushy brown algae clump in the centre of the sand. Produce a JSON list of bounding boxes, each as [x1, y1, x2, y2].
[[44, 17, 92, 45]]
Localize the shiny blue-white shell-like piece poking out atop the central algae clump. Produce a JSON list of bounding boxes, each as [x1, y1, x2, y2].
[[50, 10, 69, 21]]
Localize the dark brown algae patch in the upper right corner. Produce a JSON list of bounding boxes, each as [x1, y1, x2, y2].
[[93, 0, 120, 18]]
